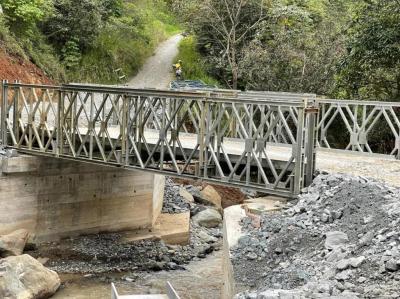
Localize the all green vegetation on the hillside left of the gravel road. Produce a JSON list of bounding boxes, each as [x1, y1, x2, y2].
[[0, 0, 179, 83]]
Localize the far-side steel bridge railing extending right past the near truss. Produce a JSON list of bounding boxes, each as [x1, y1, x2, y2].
[[234, 92, 400, 159]]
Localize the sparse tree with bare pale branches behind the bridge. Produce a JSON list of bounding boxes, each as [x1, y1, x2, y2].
[[194, 0, 266, 89]]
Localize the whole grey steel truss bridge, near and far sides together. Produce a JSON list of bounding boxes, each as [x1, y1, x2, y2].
[[1, 81, 400, 197]]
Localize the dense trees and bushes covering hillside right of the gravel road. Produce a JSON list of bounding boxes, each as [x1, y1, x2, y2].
[[169, 0, 400, 101]]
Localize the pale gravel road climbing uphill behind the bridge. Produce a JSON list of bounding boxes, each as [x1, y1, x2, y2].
[[128, 34, 182, 89]]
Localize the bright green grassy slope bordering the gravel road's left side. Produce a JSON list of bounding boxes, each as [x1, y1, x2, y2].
[[68, 0, 179, 83]]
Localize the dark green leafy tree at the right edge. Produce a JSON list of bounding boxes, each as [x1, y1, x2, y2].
[[337, 0, 400, 101]]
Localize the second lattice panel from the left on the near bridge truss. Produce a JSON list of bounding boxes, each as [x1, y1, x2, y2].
[[59, 91, 127, 164]]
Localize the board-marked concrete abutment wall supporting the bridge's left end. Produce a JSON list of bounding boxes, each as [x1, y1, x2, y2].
[[0, 156, 165, 242]]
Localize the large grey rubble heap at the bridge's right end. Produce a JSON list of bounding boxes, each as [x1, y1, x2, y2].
[[232, 174, 400, 299]]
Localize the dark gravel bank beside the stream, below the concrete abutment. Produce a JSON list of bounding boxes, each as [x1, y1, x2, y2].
[[31, 222, 222, 274]]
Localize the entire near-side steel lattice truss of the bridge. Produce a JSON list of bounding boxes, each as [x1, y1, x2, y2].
[[2, 83, 305, 195]]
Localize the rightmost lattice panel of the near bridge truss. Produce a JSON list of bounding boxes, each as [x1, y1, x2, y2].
[[205, 102, 304, 188]]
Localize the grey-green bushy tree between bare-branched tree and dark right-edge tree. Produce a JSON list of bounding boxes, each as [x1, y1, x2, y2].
[[240, 1, 348, 94]]
